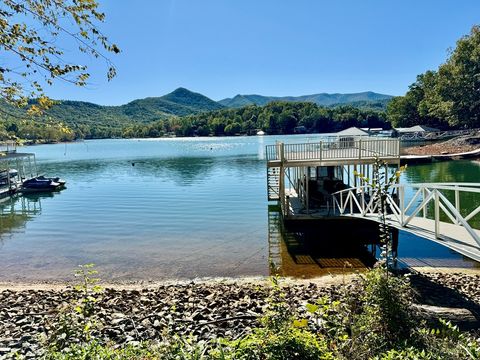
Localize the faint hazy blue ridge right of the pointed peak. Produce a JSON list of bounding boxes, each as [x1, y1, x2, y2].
[[219, 91, 392, 108]]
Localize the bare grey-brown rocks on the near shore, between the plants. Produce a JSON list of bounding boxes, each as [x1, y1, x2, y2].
[[0, 273, 480, 358]]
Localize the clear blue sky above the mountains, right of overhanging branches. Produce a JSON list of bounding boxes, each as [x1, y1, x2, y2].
[[43, 0, 480, 105]]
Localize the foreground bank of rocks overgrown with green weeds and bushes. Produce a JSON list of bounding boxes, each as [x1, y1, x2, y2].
[[0, 269, 480, 360]]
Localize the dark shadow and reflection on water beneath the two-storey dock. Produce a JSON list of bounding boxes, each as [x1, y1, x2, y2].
[[268, 206, 378, 278]]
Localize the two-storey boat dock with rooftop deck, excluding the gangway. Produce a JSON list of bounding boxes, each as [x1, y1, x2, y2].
[[266, 137, 400, 220]]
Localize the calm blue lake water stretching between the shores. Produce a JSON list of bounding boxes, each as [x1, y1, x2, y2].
[[0, 135, 480, 281]]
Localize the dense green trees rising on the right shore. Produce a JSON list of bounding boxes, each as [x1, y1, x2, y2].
[[387, 26, 480, 128]]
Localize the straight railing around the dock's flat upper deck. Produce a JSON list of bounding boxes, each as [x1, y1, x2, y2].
[[266, 137, 400, 161]]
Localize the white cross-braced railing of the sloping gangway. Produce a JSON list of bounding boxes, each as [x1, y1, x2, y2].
[[332, 183, 480, 247]]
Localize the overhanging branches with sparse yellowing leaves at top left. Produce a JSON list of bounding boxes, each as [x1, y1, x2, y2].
[[0, 0, 120, 111]]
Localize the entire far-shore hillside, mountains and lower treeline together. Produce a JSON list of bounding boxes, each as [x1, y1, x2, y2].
[[0, 88, 389, 142]]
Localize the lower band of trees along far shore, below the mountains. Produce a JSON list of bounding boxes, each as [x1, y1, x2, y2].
[[0, 102, 389, 142]]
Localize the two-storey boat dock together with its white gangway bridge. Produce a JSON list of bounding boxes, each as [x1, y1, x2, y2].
[[266, 137, 480, 261]]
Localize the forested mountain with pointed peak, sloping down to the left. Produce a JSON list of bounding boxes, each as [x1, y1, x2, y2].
[[0, 88, 224, 141]]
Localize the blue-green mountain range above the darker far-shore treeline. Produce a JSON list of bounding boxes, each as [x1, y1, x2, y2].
[[0, 88, 391, 126]]
